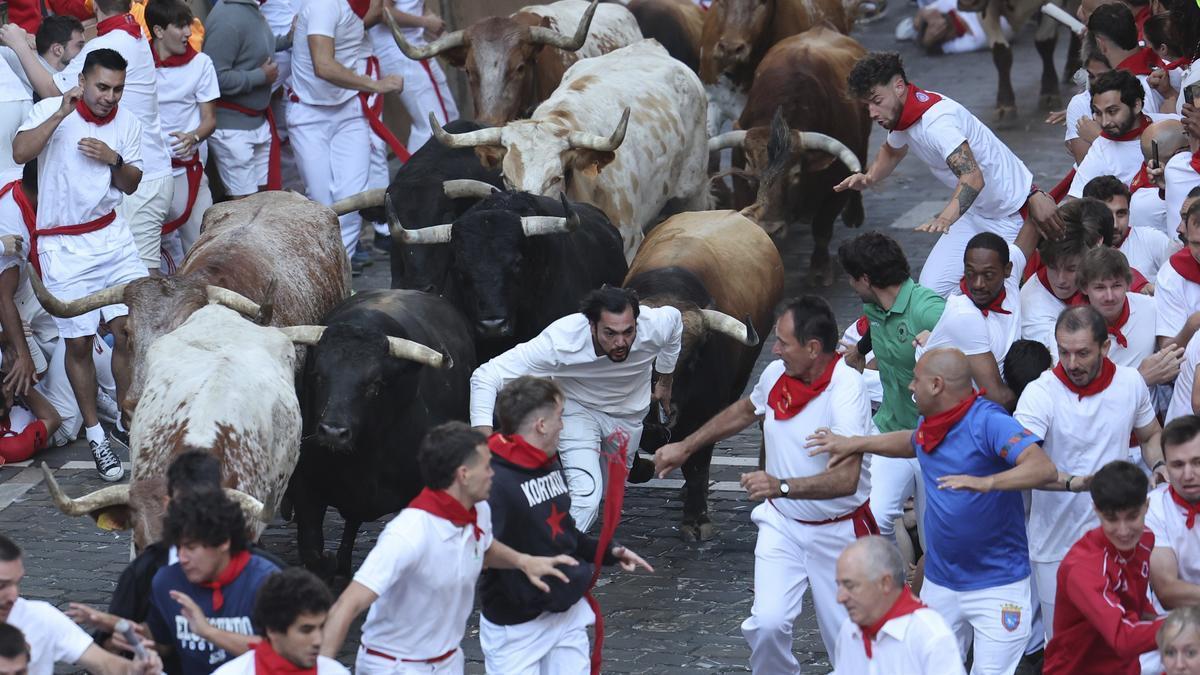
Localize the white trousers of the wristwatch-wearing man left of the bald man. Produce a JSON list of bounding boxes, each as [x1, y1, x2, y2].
[[742, 499, 864, 675]]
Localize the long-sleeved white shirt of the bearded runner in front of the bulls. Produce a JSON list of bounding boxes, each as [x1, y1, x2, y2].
[[470, 305, 683, 426]]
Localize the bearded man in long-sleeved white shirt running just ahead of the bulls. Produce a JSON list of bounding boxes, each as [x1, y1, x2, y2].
[[470, 286, 683, 532]]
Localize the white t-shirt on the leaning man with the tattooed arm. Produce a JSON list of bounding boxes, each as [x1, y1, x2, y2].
[[887, 94, 1033, 219]]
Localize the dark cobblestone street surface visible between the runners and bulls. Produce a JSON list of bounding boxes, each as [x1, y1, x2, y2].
[[7, 10, 1069, 675]]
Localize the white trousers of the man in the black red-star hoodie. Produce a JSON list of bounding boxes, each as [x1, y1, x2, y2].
[[479, 598, 595, 675]]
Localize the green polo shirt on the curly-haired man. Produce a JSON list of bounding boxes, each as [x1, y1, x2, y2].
[[863, 279, 946, 434]]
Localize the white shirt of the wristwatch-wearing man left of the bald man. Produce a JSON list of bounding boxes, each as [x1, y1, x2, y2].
[[750, 359, 871, 521]]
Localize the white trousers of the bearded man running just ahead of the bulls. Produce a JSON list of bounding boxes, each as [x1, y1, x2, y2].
[[558, 399, 646, 532]]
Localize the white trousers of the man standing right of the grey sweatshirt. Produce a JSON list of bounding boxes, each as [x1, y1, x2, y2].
[[288, 97, 371, 256]]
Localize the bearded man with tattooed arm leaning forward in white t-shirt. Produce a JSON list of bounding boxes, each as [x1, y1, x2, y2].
[[834, 52, 1057, 297]]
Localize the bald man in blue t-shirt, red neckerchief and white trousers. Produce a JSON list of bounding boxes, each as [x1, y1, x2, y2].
[[809, 348, 1058, 674]]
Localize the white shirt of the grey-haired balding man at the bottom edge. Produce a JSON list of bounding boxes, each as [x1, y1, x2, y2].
[[833, 608, 964, 675]]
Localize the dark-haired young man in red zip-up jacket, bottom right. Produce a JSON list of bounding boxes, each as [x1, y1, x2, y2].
[[1043, 460, 1163, 675]]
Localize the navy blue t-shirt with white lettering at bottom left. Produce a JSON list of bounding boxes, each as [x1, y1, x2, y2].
[[146, 555, 280, 675]]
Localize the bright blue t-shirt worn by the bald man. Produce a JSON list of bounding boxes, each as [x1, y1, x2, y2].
[[912, 396, 1042, 591]]
